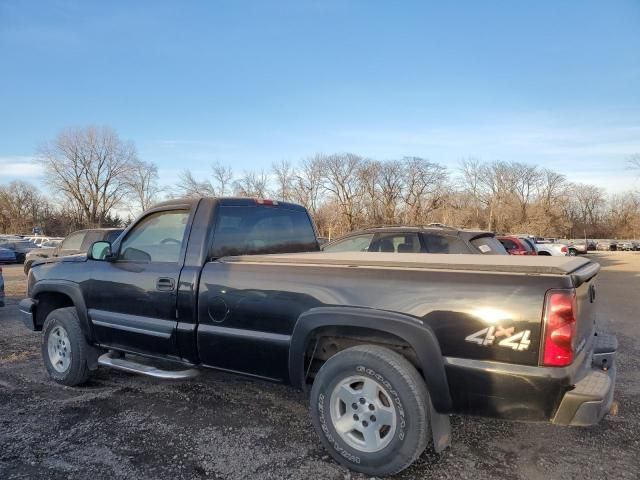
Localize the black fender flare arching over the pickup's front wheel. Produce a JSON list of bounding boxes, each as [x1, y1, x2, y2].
[[30, 280, 93, 341]]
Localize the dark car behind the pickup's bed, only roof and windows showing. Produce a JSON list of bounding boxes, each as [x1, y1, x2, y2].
[[322, 225, 507, 255]]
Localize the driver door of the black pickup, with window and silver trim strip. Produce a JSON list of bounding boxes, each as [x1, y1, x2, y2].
[[87, 209, 189, 356]]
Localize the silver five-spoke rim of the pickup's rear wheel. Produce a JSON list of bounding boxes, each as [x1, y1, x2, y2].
[[330, 376, 397, 452]]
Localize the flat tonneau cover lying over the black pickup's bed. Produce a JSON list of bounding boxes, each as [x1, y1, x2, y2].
[[220, 252, 597, 275]]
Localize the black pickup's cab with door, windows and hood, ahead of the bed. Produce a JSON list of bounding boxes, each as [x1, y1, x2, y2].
[[29, 198, 319, 363]]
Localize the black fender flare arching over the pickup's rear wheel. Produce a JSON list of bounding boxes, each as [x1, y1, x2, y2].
[[289, 307, 452, 412]]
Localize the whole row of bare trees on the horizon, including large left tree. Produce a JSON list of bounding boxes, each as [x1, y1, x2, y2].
[[0, 127, 640, 238]]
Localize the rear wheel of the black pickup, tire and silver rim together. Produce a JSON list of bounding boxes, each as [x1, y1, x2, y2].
[[311, 345, 431, 475]]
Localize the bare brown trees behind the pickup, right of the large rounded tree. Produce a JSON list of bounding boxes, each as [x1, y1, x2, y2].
[[174, 153, 640, 238]]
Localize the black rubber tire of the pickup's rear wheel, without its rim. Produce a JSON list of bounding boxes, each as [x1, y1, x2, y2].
[[311, 345, 431, 476]]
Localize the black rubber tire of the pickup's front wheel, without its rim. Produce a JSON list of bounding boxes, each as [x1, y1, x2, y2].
[[42, 307, 90, 387]]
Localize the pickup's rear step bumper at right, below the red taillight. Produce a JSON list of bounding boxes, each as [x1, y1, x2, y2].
[[551, 335, 618, 427]]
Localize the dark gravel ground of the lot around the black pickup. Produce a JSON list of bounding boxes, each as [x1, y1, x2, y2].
[[0, 253, 640, 480]]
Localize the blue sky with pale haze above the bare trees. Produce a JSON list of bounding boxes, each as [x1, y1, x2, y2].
[[0, 0, 640, 192]]
